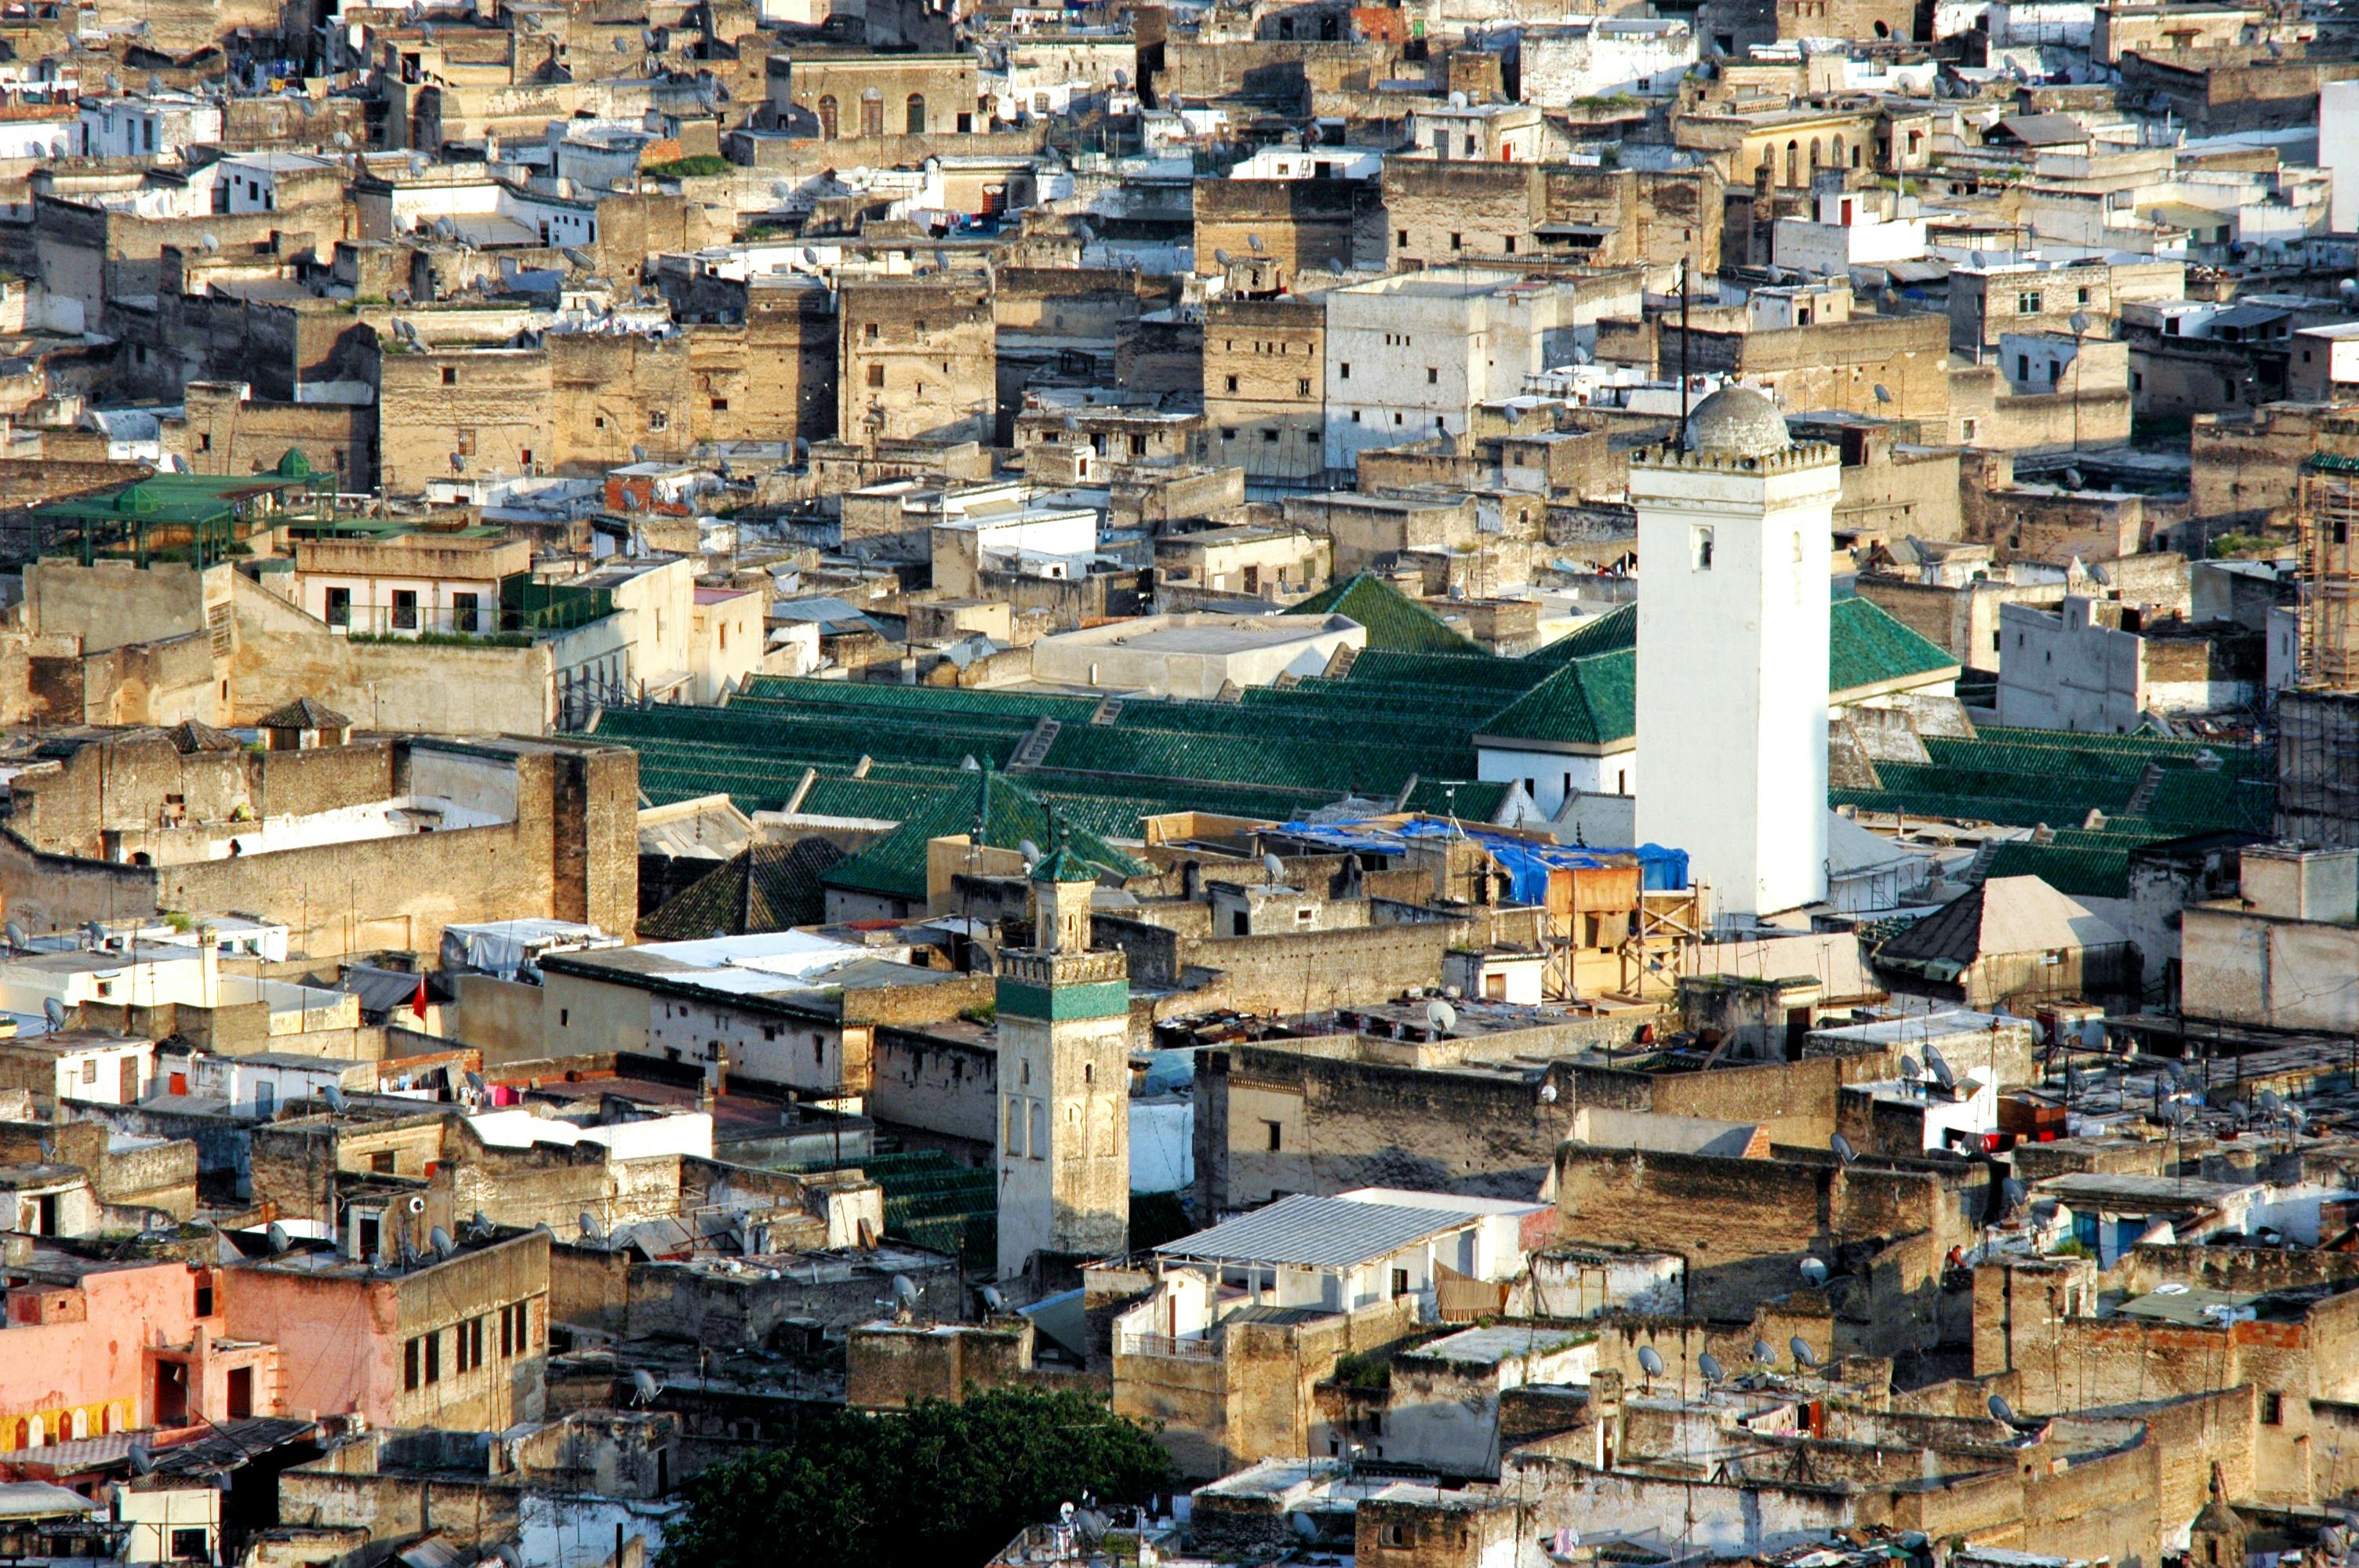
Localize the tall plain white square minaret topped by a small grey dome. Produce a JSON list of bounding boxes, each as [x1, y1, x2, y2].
[[1630, 387, 1842, 915]]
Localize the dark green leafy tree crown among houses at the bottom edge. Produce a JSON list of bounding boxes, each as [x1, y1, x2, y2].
[[660, 1388, 1170, 1568]]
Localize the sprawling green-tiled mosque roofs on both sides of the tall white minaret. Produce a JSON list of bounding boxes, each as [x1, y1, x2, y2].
[[570, 578, 2274, 898]]
